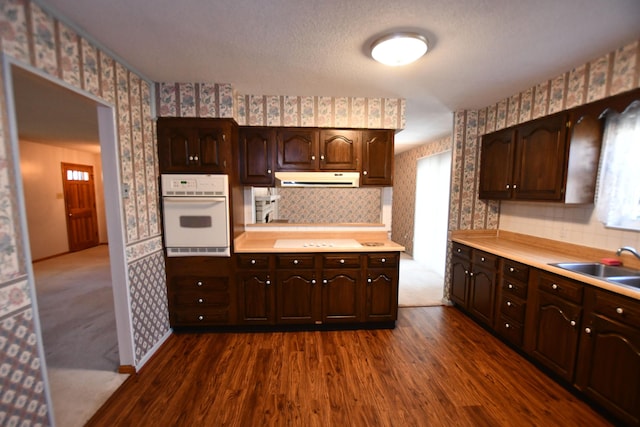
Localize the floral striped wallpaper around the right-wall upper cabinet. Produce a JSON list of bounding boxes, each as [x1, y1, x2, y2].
[[445, 40, 640, 295]]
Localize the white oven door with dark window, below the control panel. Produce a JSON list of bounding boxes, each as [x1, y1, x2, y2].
[[162, 197, 230, 256]]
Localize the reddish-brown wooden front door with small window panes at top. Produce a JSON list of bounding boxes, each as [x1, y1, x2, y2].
[[62, 163, 99, 252]]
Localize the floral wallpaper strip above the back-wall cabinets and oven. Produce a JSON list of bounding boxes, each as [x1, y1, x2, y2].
[[156, 83, 405, 129]]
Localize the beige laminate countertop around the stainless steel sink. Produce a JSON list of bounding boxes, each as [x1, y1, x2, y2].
[[450, 230, 640, 300]]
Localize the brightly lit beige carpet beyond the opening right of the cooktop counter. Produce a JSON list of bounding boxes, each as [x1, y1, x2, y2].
[[398, 252, 444, 307]]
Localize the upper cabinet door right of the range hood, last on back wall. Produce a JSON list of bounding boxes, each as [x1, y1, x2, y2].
[[362, 130, 394, 186]]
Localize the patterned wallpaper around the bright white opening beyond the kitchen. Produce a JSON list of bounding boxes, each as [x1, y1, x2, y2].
[[391, 136, 451, 254]]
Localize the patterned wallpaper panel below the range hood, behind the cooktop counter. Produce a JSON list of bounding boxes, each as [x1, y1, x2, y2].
[[277, 187, 382, 224]]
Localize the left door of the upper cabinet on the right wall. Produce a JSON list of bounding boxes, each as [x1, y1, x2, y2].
[[478, 129, 515, 199]]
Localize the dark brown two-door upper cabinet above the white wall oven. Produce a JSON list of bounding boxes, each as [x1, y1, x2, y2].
[[157, 118, 237, 173]]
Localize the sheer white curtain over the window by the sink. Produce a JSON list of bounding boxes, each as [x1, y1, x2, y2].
[[596, 101, 640, 229]]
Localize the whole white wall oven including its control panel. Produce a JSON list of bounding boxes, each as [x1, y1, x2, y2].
[[161, 174, 231, 257]]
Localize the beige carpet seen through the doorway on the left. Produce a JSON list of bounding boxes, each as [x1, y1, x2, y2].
[[33, 245, 128, 427]]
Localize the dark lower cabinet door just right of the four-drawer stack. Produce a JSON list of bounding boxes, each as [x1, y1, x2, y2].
[[532, 292, 582, 381]]
